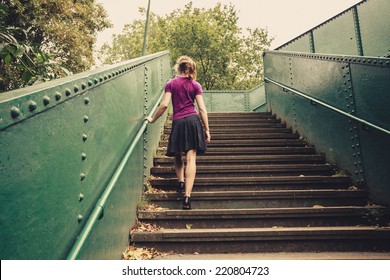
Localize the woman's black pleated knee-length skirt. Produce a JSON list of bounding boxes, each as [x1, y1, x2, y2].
[[166, 115, 207, 157]]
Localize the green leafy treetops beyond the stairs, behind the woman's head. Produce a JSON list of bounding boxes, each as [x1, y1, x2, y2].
[[99, 2, 272, 90]]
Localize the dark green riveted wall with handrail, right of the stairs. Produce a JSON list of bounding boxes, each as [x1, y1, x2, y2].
[[264, 48, 390, 204]]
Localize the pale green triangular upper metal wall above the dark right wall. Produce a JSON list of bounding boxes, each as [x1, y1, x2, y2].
[[276, 0, 390, 56]]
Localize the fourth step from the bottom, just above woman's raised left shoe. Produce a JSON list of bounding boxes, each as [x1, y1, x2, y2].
[[149, 176, 351, 192]]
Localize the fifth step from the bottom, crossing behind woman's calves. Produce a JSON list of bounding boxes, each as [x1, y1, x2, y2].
[[151, 164, 333, 178]]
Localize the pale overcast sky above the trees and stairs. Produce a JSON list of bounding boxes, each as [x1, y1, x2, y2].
[[97, 0, 361, 49]]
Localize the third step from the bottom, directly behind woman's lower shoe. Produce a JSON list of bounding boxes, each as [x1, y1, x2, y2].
[[146, 189, 367, 209]]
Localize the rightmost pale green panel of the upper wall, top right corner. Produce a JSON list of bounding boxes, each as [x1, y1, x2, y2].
[[358, 0, 390, 56]]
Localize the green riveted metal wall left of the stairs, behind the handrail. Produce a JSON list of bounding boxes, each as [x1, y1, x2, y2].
[[0, 53, 170, 259]]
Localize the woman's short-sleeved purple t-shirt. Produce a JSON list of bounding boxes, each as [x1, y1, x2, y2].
[[165, 77, 203, 120]]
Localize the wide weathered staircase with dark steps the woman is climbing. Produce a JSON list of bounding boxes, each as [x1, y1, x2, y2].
[[131, 113, 390, 254]]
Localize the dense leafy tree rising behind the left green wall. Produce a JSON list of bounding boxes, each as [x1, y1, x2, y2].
[[0, 0, 111, 91]]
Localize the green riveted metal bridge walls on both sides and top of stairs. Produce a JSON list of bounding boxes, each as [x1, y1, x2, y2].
[[0, 0, 390, 259]]
